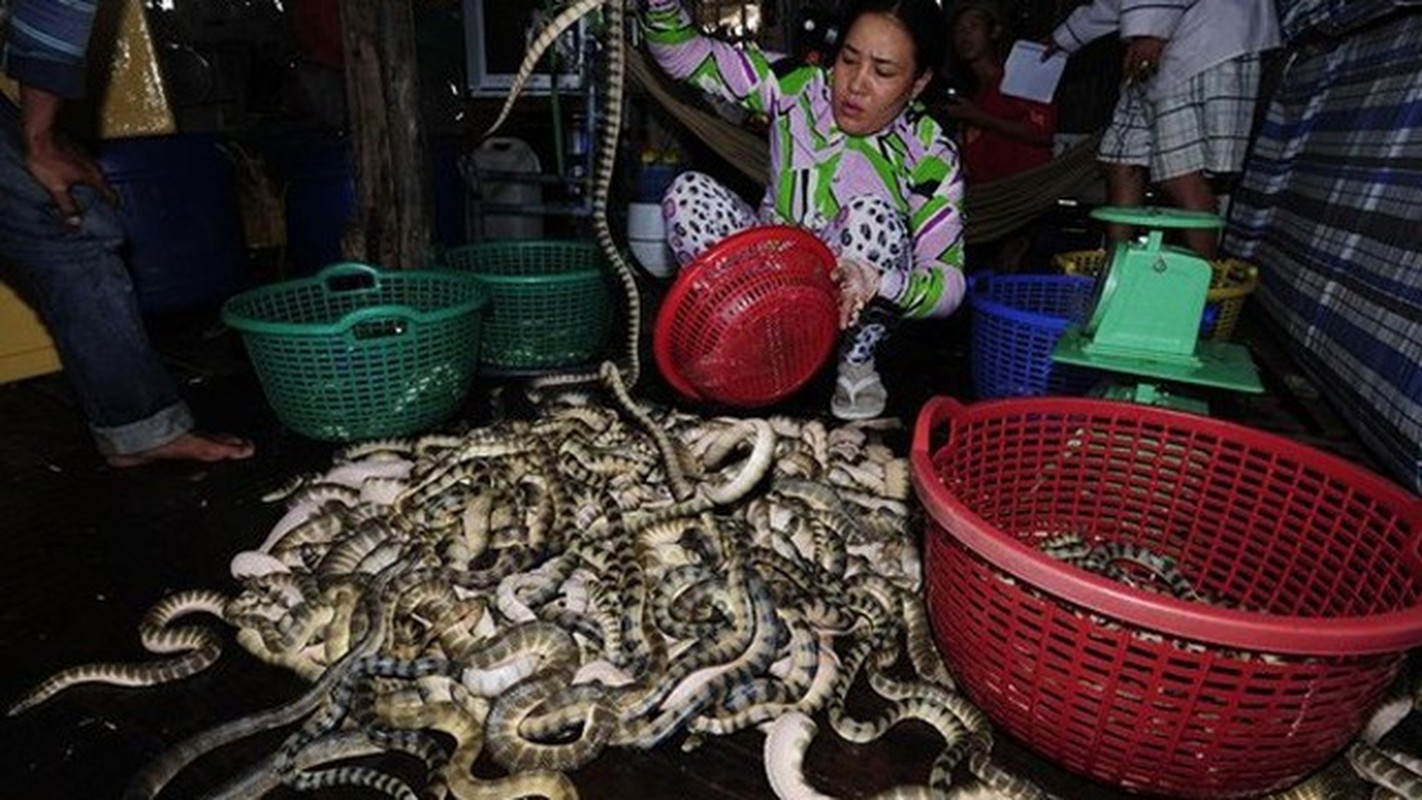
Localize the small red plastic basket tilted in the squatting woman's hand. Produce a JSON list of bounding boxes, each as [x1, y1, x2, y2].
[[653, 225, 839, 408]]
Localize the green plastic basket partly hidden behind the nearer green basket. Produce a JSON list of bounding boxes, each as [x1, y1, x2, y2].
[[437, 239, 613, 371]]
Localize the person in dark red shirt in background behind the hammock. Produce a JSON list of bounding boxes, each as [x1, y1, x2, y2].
[[943, 0, 1057, 273]]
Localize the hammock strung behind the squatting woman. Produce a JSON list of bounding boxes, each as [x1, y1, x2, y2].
[[627, 51, 1101, 244]]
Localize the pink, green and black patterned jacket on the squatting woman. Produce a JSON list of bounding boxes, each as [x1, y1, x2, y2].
[[641, 0, 964, 317]]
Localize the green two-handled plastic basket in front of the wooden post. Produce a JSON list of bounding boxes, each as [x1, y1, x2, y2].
[[222, 263, 489, 442]]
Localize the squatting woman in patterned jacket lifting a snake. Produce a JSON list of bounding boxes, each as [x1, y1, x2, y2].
[[641, 0, 966, 419]]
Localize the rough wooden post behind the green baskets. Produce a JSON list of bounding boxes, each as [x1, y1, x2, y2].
[[340, 0, 434, 269]]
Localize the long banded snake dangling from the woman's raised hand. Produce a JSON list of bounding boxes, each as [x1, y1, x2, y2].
[[485, 0, 641, 395]]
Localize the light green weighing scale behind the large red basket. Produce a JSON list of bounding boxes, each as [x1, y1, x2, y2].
[[1052, 206, 1264, 413]]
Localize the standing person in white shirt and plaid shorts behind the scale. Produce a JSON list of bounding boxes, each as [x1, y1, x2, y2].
[[1044, 0, 1280, 259]]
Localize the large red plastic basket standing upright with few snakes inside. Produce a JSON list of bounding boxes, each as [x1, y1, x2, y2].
[[912, 398, 1422, 797]]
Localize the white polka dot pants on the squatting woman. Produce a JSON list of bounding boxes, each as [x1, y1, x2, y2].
[[661, 172, 913, 364]]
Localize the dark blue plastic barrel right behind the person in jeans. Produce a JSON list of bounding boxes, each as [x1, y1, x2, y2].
[[95, 134, 249, 313]]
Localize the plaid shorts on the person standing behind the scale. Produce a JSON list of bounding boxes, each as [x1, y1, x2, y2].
[[1098, 54, 1260, 180]]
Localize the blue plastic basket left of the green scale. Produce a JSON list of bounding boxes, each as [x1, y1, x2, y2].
[[968, 274, 1105, 399]]
